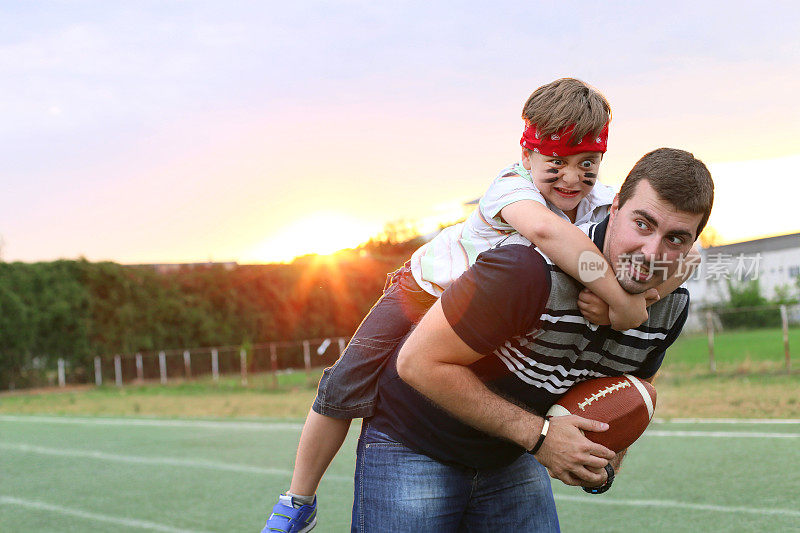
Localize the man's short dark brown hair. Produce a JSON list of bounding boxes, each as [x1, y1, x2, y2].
[[618, 148, 714, 238]]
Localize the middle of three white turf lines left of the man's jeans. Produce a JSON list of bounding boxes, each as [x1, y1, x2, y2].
[[0, 442, 353, 482]]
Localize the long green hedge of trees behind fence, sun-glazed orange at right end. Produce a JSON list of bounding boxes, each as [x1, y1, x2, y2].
[[0, 242, 418, 388]]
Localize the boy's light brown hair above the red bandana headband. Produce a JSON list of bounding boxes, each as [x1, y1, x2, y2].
[[522, 78, 611, 153]]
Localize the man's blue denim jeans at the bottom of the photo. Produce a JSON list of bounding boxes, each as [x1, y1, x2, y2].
[[350, 423, 559, 533]]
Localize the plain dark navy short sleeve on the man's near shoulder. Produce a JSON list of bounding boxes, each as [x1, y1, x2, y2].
[[441, 244, 550, 355]]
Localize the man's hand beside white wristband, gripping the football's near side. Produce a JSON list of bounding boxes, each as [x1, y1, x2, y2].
[[536, 415, 616, 486]]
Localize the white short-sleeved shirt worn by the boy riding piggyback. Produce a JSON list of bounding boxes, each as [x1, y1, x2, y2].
[[411, 162, 615, 296]]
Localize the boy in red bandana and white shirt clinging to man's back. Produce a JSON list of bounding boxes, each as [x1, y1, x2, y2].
[[262, 78, 682, 533]]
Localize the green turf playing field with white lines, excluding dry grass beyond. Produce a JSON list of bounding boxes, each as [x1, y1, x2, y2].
[[0, 415, 800, 532]]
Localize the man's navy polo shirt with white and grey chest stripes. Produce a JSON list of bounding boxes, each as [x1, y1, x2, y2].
[[370, 215, 689, 468]]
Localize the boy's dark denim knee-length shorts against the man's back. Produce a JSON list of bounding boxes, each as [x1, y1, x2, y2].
[[312, 263, 436, 419]]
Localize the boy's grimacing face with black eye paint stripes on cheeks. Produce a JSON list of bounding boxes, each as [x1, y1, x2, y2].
[[523, 152, 603, 219]]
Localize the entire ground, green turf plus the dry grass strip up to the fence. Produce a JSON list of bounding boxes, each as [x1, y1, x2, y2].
[[0, 330, 800, 532]]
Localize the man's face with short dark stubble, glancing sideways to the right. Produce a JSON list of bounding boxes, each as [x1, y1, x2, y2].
[[603, 180, 703, 294]]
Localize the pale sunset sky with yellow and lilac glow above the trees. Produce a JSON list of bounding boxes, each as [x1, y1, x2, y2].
[[0, 0, 800, 263]]
